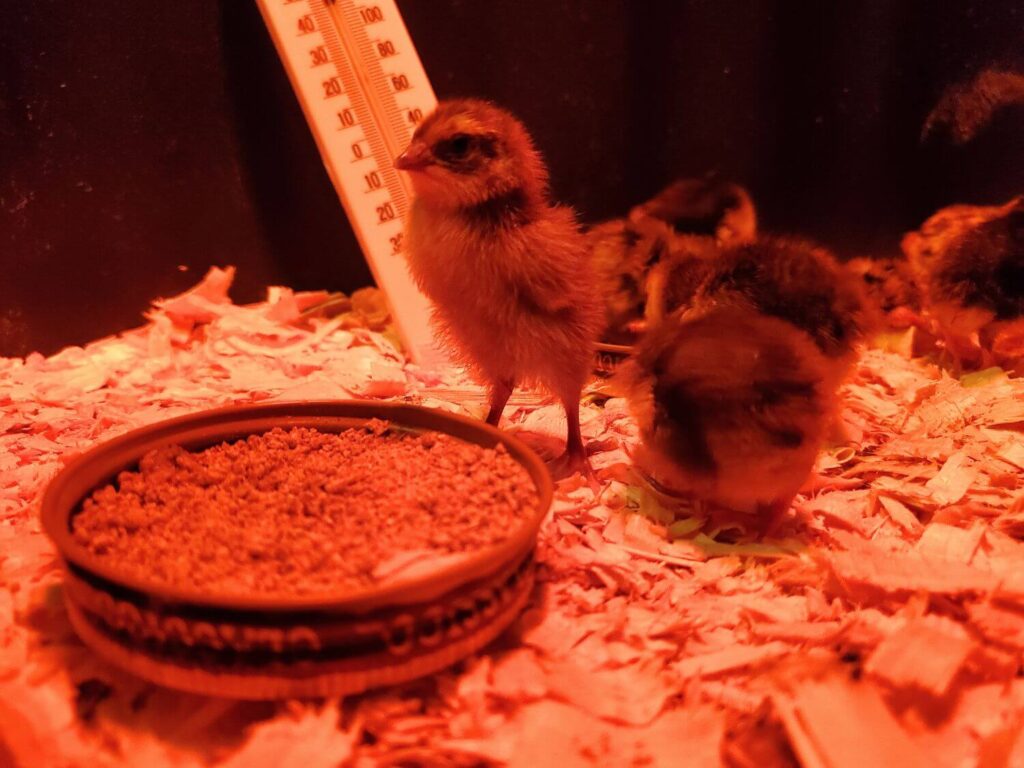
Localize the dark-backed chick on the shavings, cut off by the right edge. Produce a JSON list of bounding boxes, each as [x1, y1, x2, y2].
[[902, 196, 1024, 368]]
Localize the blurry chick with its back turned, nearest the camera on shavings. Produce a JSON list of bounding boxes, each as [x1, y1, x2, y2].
[[620, 304, 836, 535]]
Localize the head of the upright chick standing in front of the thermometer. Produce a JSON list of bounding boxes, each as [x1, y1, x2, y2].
[[395, 99, 547, 209]]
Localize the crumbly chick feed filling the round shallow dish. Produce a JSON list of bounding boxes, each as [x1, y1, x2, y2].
[[72, 420, 537, 595]]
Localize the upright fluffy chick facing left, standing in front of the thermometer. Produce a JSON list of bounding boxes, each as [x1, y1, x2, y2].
[[395, 99, 602, 476]]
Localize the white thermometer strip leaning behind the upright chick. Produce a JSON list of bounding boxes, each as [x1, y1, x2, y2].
[[258, 0, 443, 365]]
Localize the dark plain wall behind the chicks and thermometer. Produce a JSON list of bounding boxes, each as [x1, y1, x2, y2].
[[0, 0, 1024, 355]]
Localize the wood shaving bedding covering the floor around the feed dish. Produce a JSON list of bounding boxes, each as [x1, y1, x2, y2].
[[0, 269, 1024, 768]]
